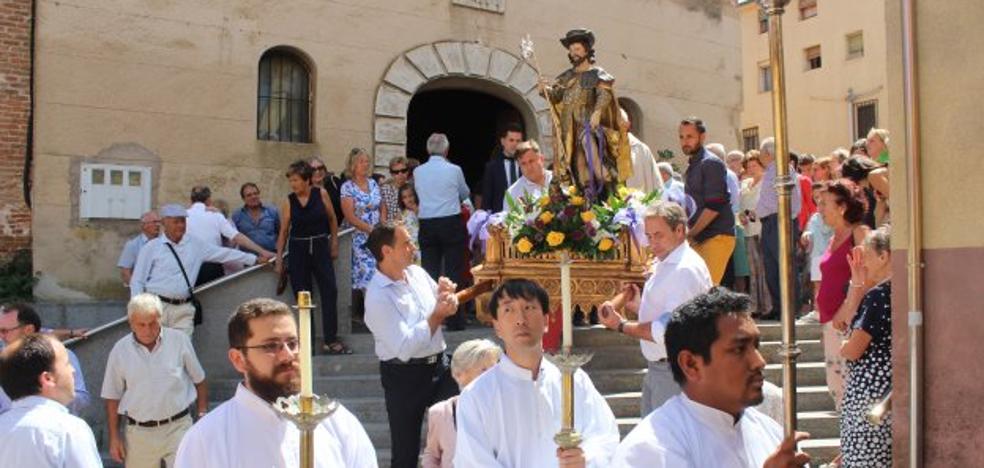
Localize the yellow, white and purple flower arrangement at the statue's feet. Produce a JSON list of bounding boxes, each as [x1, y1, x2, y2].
[[502, 184, 659, 259]]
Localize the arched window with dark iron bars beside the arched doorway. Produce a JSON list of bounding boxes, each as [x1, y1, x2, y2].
[[256, 49, 312, 143]]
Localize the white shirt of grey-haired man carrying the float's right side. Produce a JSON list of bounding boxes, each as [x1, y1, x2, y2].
[[639, 241, 714, 361]]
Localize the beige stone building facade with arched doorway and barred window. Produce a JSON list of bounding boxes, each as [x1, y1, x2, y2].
[[26, 0, 741, 300]]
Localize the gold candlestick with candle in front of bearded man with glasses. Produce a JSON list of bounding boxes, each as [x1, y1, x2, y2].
[[273, 291, 338, 468]]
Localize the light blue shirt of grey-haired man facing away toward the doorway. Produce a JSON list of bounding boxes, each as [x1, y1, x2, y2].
[[413, 155, 471, 219]]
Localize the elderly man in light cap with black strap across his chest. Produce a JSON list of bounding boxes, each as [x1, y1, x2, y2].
[[130, 204, 271, 336]]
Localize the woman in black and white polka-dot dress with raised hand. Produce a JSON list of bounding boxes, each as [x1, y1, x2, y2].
[[841, 227, 892, 467]]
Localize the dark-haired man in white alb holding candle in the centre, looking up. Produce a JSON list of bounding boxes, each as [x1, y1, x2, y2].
[[454, 279, 619, 468]]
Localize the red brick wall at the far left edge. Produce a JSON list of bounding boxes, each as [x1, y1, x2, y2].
[[0, 0, 32, 259]]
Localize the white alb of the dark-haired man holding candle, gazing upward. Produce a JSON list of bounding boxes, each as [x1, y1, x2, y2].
[[454, 355, 619, 468]]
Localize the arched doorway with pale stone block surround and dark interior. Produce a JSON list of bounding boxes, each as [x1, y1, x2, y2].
[[373, 41, 552, 181]]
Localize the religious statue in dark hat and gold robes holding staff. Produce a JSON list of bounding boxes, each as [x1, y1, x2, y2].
[[541, 29, 632, 201]]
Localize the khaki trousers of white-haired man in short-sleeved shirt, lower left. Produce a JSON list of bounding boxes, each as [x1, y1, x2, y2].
[[126, 415, 191, 468]]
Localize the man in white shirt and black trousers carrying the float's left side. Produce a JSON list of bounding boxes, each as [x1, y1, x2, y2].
[[366, 224, 458, 468]]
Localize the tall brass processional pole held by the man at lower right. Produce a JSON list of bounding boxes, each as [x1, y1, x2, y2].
[[761, 0, 800, 437]]
